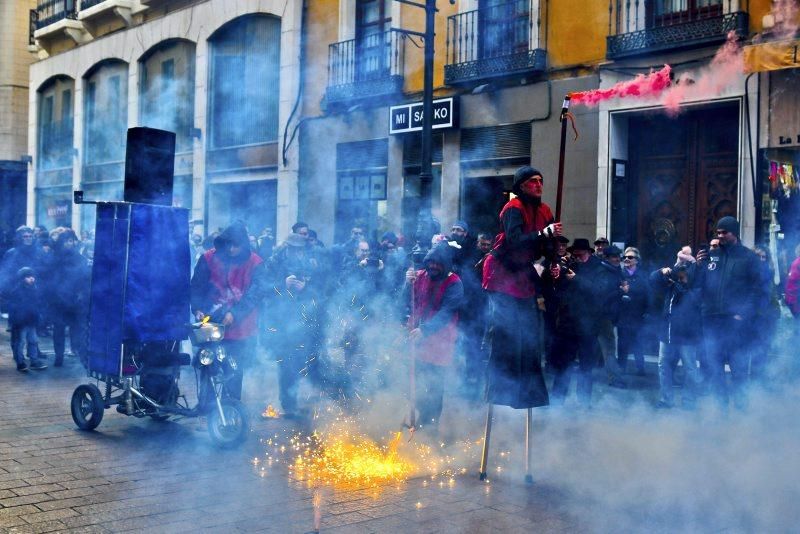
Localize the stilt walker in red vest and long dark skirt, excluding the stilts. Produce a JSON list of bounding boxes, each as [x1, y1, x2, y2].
[[483, 166, 561, 408]]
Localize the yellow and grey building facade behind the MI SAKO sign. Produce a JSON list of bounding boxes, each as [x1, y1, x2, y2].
[[299, 0, 604, 247]]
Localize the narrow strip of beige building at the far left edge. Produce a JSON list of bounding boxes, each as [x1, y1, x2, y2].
[[0, 0, 36, 248]]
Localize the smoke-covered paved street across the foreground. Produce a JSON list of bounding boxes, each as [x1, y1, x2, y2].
[[0, 324, 800, 533]]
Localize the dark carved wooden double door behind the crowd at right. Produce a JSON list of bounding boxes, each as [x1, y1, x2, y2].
[[612, 104, 739, 266]]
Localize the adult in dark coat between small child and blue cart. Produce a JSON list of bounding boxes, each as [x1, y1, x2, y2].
[[46, 228, 91, 367]]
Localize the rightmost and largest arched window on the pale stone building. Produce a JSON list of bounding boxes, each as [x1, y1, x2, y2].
[[208, 15, 281, 149]]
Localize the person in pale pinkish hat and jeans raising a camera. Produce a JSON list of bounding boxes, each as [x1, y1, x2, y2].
[[650, 246, 702, 408]]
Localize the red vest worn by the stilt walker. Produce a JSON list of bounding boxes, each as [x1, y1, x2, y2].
[[483, 198, 553, 299]]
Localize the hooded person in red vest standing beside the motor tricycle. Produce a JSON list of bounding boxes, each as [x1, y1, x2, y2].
[[191, 222, 266, 399]]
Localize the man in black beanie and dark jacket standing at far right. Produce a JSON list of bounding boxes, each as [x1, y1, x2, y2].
[[696, 216, 769, 408]]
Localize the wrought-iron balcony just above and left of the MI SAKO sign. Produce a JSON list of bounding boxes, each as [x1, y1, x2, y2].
[[325, 29, 407, 106]]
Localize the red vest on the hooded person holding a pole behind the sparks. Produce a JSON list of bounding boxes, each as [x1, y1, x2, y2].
[[408, 270, 461, 366]]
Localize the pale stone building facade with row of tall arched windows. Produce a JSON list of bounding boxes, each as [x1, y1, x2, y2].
[[27, 0, 302, 239]]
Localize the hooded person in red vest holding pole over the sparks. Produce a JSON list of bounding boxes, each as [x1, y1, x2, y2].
[[404, 242, 464, 429]]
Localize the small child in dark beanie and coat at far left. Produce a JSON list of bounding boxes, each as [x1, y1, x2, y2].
[[8, 266, 47, 372]]
